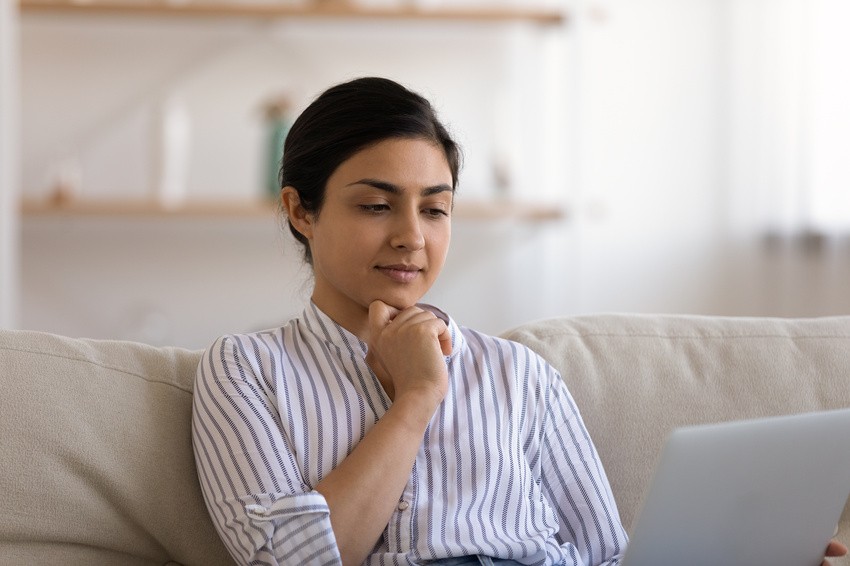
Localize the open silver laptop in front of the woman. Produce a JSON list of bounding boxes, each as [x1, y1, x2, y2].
[[623, 409, 850, 566]]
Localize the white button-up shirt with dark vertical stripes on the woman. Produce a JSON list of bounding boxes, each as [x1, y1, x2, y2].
[[192, 303, 627, 565]]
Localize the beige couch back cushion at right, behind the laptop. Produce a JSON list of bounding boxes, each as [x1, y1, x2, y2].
[[505, 315, 850, 564]]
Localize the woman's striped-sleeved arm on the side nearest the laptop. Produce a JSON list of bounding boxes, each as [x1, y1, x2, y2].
[[542, 365, 628, 565]]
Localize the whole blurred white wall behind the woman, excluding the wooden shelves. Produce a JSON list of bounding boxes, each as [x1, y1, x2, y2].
[[14, 0, 850, 347]]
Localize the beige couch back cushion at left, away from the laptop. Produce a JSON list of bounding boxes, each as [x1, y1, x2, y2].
[[0, 331, 232, 566]]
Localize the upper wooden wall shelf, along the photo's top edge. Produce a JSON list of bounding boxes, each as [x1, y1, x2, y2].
[[19, 0, 566, 25]]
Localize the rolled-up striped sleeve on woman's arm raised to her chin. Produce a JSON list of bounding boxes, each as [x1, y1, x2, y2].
[[192, 337, 341, 565]]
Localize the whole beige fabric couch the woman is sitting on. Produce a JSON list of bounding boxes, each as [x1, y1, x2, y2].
[[0, 315, 850, 566]]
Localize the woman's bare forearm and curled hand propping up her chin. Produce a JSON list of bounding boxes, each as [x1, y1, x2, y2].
[[316, 301, 451, 564]]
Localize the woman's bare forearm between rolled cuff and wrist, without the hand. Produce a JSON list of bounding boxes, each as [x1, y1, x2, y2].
[[315, 395, 436, 565]]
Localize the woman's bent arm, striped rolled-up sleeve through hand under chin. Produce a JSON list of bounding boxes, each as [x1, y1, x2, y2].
[[193, 307, 447, 564]]
